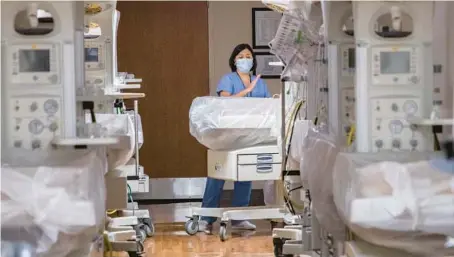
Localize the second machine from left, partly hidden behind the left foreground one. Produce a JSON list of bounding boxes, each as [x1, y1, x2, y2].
[[84, 1, 154, 256]]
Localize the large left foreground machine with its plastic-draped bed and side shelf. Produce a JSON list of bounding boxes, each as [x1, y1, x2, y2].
[[1, 1, 110, 256]]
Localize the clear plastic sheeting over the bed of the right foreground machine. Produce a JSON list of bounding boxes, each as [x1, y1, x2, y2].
[[333, 152, 454, 256]]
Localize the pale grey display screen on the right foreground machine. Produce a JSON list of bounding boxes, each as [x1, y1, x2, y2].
[[380, 52, 410, 74]]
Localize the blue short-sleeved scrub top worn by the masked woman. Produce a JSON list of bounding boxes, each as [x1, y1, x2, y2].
[[216, 72, 271, 98]]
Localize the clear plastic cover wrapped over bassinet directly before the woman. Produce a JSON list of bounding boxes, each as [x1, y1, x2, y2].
[[189, 96, 281, 151]]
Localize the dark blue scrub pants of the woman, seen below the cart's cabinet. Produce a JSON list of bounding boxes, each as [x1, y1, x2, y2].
[[202, 178, 252, 224]]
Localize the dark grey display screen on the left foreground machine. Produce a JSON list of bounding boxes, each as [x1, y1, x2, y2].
[[19, 49, 50, 72]]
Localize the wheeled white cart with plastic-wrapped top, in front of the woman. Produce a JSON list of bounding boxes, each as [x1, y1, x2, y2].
[[185, 97, 284, 241]]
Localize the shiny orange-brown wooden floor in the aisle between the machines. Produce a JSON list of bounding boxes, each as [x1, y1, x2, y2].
[[145, 221, 274, 257]]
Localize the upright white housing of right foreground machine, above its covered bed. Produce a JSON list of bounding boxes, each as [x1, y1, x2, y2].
[[353, 1, 433, 152]]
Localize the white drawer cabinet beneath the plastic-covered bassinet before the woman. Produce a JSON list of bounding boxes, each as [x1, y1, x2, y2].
[[208, 145, 282, 181]]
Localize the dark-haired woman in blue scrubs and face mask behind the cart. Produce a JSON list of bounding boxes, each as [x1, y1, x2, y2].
[[199, 44, 271, 233]]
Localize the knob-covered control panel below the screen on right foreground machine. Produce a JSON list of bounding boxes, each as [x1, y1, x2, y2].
[[371, 98, 427, 152]]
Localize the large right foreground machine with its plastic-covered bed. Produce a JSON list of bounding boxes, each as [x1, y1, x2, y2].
[[333, 2, 454, 256]]
